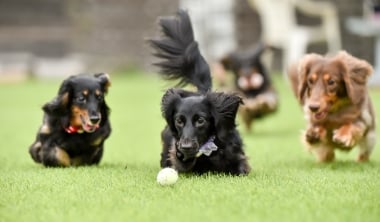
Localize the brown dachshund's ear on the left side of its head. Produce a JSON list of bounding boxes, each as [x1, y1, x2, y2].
[[296, 53, 323, 104]]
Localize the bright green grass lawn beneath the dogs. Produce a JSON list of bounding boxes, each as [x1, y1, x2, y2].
[[0, 72, 380, 222]]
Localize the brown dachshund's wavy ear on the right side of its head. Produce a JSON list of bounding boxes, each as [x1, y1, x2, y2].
[[336, 51, 373, 105]]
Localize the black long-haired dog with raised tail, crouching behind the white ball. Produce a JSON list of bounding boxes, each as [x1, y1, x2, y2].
[[149, 10, 250, 175]]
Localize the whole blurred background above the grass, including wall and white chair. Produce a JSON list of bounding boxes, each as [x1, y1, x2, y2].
[[0, 0, 380, 82]]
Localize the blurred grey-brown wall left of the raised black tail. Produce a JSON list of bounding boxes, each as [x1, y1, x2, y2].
[[0, 0, 178, 70]]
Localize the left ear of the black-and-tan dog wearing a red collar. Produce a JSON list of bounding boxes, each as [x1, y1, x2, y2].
[[42, 77, 72, 116]]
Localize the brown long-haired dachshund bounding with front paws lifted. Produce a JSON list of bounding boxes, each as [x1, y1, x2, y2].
[[288, 51, 376, 162]]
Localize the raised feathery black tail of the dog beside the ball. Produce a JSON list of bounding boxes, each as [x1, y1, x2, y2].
[[149, 10, 212, 93]]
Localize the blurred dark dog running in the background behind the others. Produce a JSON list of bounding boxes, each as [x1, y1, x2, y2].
[[221, 44, 278, 131]]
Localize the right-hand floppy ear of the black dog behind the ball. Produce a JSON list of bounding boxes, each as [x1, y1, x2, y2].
[[206, 92, 243, 138]]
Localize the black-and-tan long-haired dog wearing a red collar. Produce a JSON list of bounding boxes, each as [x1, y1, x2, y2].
[[29, 73, 111, 167]]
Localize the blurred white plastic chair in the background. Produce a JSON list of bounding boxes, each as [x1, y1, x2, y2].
[[248, 0, 341, 71]]
